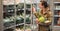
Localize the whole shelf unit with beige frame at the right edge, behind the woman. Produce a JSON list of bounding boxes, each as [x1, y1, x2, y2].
[[52, 0, 60, 31]]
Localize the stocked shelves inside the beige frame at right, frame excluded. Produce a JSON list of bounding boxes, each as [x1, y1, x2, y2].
[[54, 2, 60, 26]]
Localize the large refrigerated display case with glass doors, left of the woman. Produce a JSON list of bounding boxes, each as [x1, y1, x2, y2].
[[2, 0, 37, 31]]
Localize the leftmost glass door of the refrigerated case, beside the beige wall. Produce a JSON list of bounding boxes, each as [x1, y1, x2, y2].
[[3, 0, 16, 31]]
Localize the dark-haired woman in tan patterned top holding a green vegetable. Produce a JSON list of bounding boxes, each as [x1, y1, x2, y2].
[[33, 1, 52, 31]]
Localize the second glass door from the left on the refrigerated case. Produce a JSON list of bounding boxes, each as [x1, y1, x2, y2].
[[15, 0, 25, 31]]
